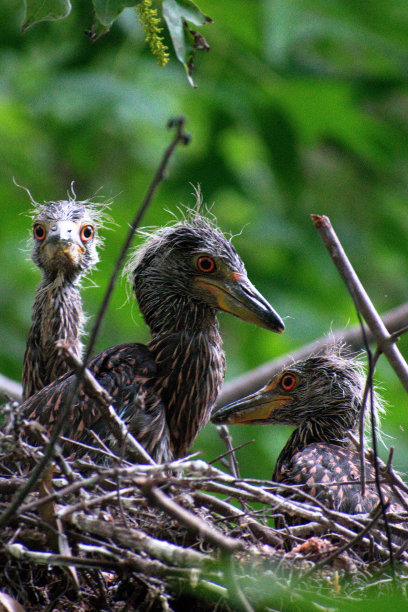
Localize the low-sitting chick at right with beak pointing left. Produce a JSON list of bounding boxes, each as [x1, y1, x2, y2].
[[211, 345, 402, 524]]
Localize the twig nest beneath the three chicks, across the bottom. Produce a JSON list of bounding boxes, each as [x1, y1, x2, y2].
[[0, 411, 408, 612]]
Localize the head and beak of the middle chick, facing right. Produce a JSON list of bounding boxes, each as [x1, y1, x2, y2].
[[127, 213, 284, 333]]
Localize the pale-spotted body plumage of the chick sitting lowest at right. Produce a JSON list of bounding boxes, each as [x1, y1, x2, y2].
[[274, 443, 402, 514]]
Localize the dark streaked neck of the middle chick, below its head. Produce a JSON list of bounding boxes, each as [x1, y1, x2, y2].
[[149, 300, 225, 457]]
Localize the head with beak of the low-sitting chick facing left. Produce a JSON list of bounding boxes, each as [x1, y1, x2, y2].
[[211, 349, 378, 437]]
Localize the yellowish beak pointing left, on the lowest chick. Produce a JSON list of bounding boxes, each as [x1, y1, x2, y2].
[[211, 385, 293, 425]]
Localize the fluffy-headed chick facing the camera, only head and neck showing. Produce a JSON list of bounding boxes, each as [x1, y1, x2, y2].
[[22, 194, 106, 400]]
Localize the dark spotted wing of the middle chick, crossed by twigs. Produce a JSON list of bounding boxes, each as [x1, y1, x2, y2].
[[23, 343, 167, 462]]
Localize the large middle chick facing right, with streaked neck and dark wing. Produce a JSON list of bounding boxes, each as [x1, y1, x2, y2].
[[22, 209, 284, 462]]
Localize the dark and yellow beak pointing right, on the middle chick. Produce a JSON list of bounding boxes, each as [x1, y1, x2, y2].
[[196, 272, 285, 334]]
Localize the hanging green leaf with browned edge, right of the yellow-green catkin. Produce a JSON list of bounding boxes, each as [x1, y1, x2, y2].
[[163, 0, 212, 87]]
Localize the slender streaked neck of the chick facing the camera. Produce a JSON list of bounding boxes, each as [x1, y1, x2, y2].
[[23, 275, 84, 399]]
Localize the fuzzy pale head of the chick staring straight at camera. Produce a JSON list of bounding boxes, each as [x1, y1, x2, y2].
[[31, 199, 103, 277]]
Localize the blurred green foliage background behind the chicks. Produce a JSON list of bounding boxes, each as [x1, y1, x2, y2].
[[0, 0, 408, 477]]
